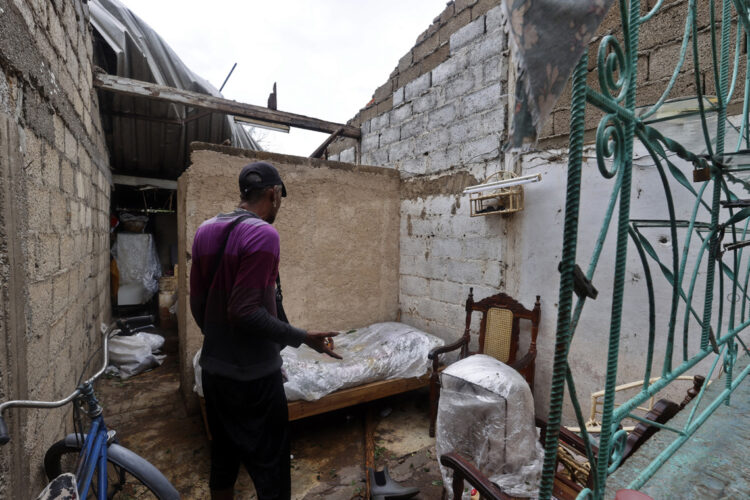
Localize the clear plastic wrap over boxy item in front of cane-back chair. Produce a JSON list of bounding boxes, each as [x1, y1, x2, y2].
[[435, 354, 544, 498]]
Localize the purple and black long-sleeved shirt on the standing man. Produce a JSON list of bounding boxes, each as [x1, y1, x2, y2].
[[190, 209, 306, 380]]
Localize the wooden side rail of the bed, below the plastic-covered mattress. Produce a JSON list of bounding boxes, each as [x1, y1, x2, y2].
[[289, 373, 430, 420]]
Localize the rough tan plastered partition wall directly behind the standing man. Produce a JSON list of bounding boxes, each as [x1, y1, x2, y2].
[[178, 144, 399, 401]]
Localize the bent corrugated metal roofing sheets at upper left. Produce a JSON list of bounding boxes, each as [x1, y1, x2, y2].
[[89, 0, 260, 179]]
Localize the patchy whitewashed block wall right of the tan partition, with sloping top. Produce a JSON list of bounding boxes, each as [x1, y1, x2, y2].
[[330, 1, 512, 340]]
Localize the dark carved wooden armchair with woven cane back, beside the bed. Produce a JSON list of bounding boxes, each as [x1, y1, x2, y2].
[[428, 288, 541, 436]]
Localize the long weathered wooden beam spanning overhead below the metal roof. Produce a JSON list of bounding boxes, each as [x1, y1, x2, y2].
[[94, 71, 361, 139]]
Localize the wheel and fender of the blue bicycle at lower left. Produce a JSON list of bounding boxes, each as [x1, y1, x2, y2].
[[44, 434, 180, 500]]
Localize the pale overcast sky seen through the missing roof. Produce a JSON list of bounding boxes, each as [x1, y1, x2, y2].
[[121, 0, 446, 156]]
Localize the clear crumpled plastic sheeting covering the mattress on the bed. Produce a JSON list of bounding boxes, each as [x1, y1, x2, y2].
[[281, 322, 444, 401]]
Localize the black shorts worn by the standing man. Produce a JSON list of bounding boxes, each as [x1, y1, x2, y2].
[[202, 370, 291, 500]]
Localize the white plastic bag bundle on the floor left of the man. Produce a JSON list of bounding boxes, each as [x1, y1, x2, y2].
[[107, 332, 165, 380]]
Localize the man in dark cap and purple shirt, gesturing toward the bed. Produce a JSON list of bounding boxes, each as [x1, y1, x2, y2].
[[190, 162, 341, 500]]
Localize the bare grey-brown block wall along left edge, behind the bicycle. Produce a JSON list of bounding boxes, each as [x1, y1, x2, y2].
[[0, 0, 110, 498]]
